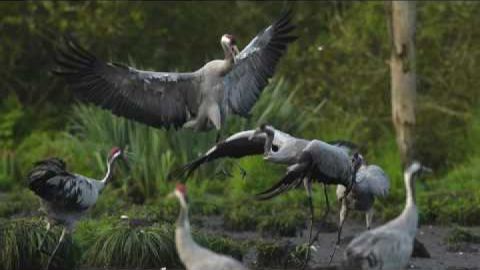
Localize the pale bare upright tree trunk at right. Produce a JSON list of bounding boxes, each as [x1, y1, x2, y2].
[[387, 1, 416, 166]]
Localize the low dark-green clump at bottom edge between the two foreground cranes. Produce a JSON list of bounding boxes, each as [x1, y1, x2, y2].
[[255, 241, 307, 267]]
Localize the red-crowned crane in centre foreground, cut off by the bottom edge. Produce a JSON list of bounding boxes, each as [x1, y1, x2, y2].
[[168, 184, 248, 270]]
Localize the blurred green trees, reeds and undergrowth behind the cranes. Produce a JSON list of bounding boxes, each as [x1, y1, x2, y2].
[[0, 1, 480, 268]]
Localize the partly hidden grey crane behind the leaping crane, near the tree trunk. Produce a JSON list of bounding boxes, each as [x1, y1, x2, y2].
[[330, 158, 390, 262]]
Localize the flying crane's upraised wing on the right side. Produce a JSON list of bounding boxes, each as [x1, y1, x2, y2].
[[224, 11, 297, 116]]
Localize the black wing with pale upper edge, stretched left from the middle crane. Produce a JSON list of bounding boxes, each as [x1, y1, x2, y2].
[[169, 130, 266, 178]]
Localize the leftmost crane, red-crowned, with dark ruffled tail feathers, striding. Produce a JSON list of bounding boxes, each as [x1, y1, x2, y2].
[[27, 147, 125, 270]]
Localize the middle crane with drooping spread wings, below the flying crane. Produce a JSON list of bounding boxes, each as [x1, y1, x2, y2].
[[171, 125, 361, 268]]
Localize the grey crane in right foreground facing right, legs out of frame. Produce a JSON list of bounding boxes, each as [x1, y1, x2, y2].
[[344, 162, 432, 270]]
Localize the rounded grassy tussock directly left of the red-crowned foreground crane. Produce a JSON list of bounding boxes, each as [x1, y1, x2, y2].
[[85, 223, 180, 268]]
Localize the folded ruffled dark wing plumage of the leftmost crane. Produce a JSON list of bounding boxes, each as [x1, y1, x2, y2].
[[27, 158, 96, 210]]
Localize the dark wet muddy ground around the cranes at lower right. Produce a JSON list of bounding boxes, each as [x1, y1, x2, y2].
[[199, 217, 480, 270]]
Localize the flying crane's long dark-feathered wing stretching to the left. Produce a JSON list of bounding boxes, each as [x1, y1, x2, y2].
[[53, 38, 199, 128]]
